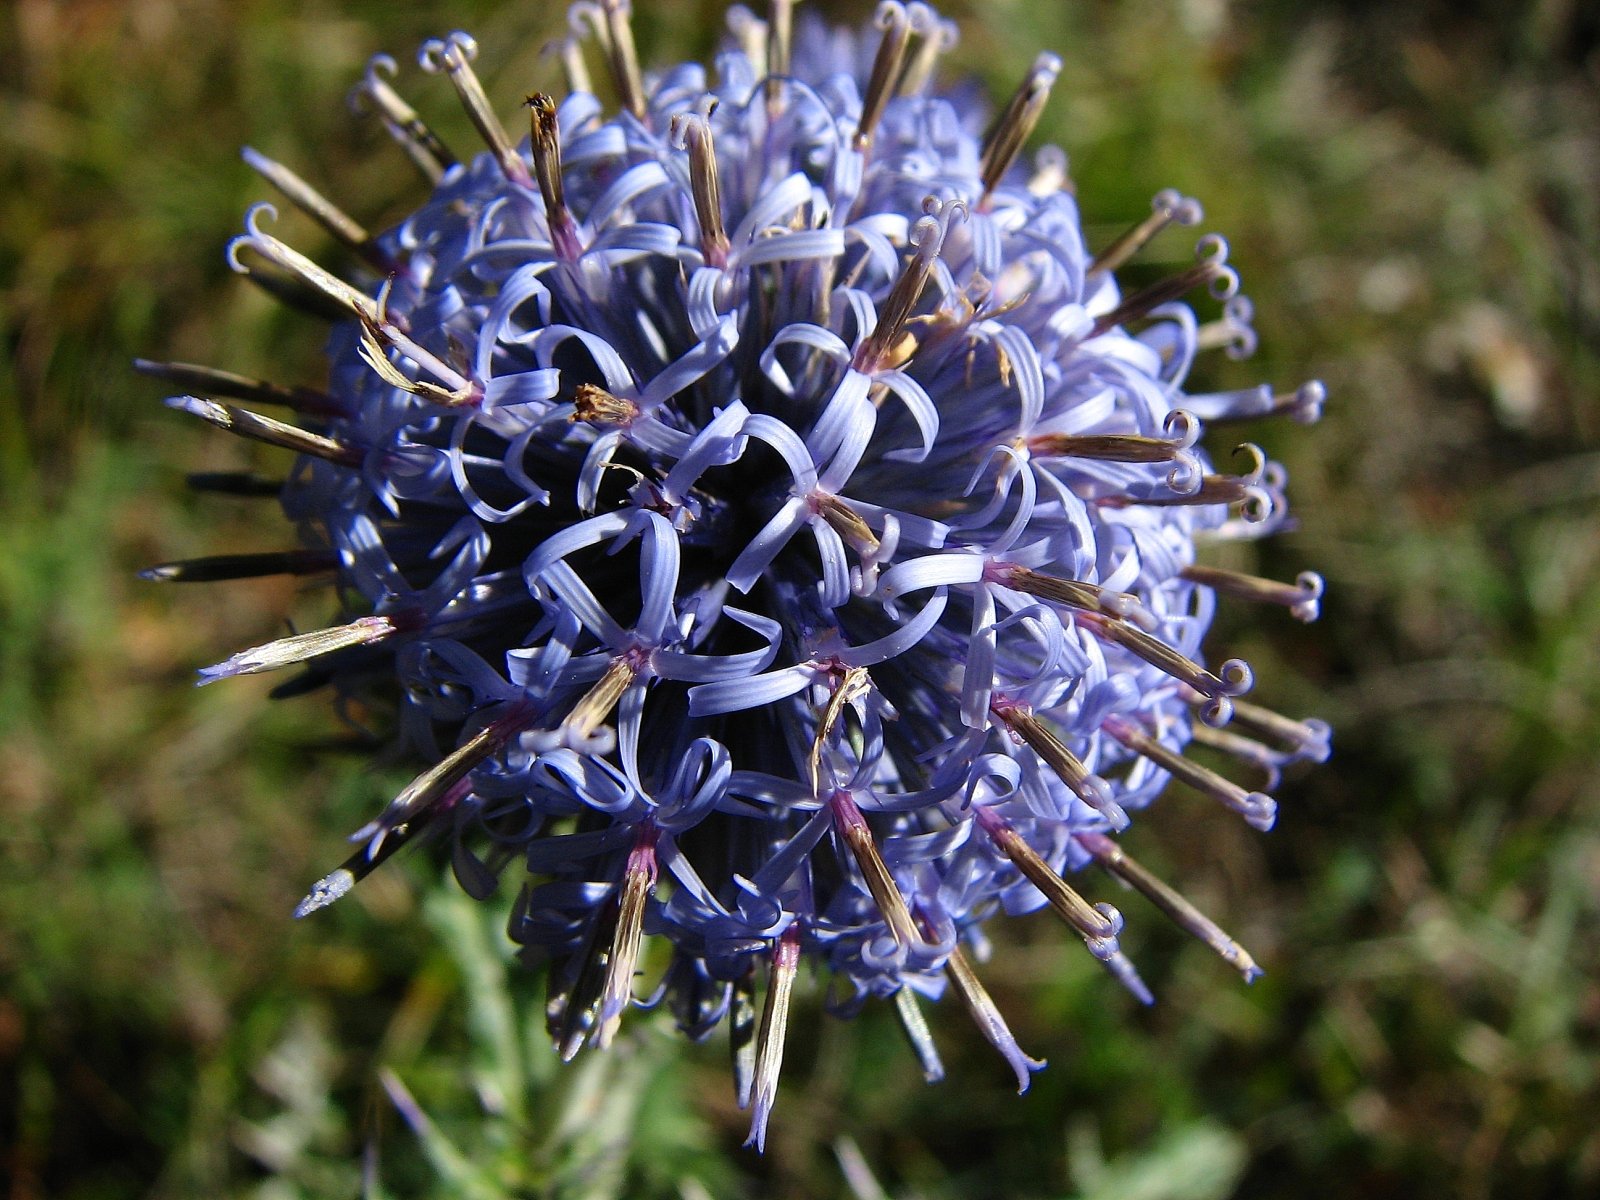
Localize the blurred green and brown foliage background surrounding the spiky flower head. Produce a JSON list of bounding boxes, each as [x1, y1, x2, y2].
[[0, 0, 1600, 1200]]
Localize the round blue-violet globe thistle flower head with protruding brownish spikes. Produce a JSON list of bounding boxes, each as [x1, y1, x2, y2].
[[141, 0, 1328, 1146]]
